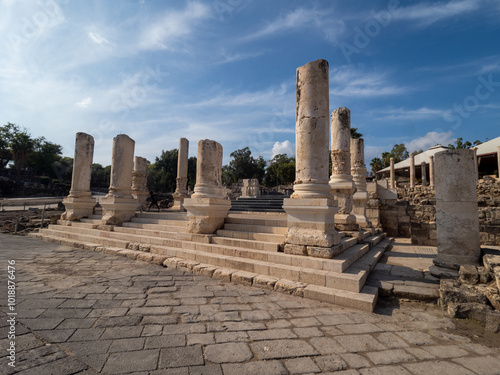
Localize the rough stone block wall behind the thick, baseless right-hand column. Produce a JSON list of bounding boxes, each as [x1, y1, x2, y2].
[[379, 178, 500, 246]]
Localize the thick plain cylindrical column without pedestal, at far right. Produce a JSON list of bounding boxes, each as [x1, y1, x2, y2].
[[434, 149, 481, 269]]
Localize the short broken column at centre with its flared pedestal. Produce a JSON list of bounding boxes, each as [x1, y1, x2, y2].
[[184, 139, 231, 234]]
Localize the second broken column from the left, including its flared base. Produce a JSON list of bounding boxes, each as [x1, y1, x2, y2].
[[99, 134, 139, 229]]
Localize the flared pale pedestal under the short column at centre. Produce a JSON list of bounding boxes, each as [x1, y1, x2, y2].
[[183, 198, 231, 234]]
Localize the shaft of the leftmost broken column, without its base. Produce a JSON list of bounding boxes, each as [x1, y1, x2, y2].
[[69, 133, 94, 198]]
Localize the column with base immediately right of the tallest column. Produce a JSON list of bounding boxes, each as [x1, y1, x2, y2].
[[330, 107, 359, 231]]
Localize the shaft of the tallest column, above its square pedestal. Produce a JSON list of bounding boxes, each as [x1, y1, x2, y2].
[[293, 60, 331, 198]]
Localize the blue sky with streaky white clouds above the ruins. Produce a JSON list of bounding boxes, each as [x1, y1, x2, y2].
[[0, 0, 500, 172]]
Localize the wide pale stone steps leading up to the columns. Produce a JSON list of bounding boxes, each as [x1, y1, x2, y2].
[[29, 212, 391, 311]]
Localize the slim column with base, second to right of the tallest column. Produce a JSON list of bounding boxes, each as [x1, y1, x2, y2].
[[351, 138, 372, 228]]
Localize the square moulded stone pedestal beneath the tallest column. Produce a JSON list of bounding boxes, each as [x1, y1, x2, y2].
[[283, 198, 340, 255]]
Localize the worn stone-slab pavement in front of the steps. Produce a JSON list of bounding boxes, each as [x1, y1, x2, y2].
[[0, 234, 500, 375]]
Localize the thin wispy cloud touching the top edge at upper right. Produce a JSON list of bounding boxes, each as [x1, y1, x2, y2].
[[392, 0, 481, 26]]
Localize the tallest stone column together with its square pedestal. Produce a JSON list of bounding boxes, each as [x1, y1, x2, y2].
[[283, 60, 340, 258]]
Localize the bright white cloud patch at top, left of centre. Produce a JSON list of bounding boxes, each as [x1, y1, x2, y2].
[[140, 2, 210, 50]]
